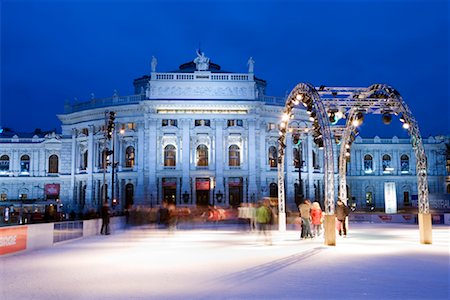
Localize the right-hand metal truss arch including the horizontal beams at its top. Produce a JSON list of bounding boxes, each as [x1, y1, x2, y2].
[[318, 84, 432, 244]]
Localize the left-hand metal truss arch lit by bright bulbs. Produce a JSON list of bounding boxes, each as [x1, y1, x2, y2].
[[278, 83, 336, 245]]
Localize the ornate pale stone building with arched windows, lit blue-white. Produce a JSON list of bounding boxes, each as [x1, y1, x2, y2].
[[0, 52, 450, 219]]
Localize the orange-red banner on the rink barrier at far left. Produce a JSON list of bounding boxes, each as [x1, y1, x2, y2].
[[0, 226, 28, 255]]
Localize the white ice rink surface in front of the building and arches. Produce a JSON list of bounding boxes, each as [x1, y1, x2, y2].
[[0, 223, 450, 300]]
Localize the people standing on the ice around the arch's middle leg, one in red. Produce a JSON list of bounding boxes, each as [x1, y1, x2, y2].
[[298, 199, 349, 240]]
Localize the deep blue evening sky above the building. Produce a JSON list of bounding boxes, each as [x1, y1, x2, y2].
[[0, 0, 450, 137]]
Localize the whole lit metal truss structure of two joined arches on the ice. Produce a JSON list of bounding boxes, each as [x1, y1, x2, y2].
[[278, 83, 432, 245]]
